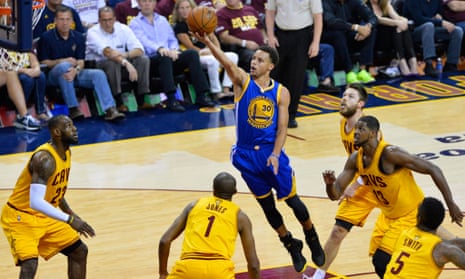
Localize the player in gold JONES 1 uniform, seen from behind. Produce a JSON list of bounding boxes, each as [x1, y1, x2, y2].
[[158, 172, 260, 279]]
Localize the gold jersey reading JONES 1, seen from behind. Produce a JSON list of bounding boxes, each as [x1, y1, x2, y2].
[[181, 197, 240, 260]]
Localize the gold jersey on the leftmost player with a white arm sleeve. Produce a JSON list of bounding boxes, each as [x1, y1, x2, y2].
[[8, 143, 71, 217]]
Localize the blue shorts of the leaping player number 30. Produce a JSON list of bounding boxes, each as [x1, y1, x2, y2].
[[231, 145, 296, 199]]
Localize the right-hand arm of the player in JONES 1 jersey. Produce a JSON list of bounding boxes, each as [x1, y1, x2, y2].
[[237, 210, 260, 279]]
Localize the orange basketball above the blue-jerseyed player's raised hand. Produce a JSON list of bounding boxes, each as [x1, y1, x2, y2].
[[187, 6, 218, 36]]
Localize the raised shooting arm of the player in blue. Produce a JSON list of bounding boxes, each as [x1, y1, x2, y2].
[[194, 33, 247, 88]]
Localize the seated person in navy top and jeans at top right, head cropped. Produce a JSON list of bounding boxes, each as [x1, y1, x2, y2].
[[404, 0, 463, 77]]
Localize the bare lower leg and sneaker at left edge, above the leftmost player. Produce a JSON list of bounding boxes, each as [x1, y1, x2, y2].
[[0, 71, 40, 131]]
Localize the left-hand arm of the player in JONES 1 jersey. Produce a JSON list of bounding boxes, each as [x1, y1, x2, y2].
[[158, 202, 196, 279]]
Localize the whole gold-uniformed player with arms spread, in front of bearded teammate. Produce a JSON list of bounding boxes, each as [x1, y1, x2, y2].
[[323, 116, 464, 278]]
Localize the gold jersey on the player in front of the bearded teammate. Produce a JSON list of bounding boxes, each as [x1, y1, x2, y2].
[[357, 141, 424, 219]]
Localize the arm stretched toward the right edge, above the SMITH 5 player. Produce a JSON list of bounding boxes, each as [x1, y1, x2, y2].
[[383, 146, 464, 226]]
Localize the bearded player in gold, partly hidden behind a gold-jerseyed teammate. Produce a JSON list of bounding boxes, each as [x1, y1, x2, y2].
[[312, 83, 377, 279]]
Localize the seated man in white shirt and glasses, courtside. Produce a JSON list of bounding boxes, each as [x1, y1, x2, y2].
[[86, 7, 150, 112]]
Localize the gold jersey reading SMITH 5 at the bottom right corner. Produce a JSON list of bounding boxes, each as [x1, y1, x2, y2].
[[384, 227, 443, 279]]
